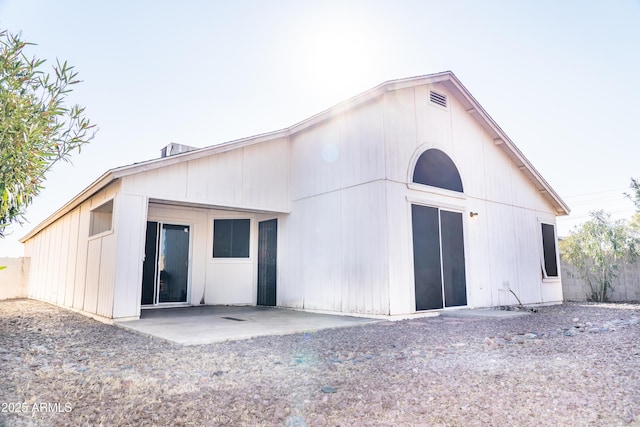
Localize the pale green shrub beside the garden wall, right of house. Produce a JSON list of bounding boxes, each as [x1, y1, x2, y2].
[[559, 210, 638, 301]]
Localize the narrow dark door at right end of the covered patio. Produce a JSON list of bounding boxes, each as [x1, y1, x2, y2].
[[258, 219, 278, 305]]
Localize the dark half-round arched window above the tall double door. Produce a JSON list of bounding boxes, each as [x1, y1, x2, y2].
[[413, 148, 462, 193]]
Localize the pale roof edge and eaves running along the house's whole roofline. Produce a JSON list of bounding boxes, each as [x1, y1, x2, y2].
[[20, 71, 570, 242]]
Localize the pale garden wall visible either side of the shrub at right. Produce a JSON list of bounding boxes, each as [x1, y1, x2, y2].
[[560, 261, 640, 302]]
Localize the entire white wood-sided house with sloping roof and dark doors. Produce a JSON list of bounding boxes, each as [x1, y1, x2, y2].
[[22, 71, 569, 320]]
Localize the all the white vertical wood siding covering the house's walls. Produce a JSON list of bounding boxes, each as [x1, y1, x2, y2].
[[21, 77, 562, 318]]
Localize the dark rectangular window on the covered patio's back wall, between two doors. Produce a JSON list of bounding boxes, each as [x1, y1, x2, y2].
[[213, 219, 250, 258]]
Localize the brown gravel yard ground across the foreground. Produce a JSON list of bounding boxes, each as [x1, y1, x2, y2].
[[0, 300, 640, 427]]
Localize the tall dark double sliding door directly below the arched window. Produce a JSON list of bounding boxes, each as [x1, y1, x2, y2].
[[411, 205, 467, 311]]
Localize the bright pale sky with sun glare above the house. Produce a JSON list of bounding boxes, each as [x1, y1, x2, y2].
[[0, 0, 640, 256]]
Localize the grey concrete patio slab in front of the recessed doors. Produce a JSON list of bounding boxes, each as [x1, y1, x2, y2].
[[116, 306, 381, 345]]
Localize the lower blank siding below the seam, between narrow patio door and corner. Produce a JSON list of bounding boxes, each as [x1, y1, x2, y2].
[[278, 181, 389, 314]]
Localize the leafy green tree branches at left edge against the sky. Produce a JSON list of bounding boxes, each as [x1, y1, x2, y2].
[[0, 31, 96, 237]]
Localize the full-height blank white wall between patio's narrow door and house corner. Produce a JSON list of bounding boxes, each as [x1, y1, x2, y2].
[[278, 102, 389, 314]]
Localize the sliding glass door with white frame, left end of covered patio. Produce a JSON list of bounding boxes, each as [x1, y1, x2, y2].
[[141, 221, 190, 305]]
